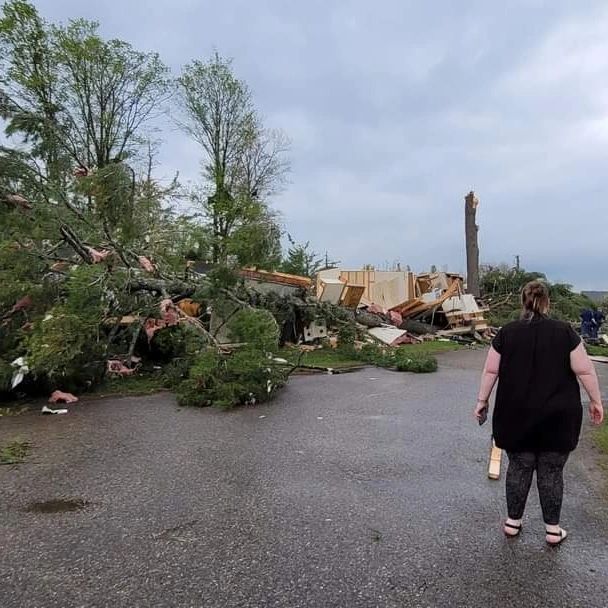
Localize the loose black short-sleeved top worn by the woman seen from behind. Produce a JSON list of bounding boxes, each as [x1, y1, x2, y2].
[[492, 317, 583, 452]]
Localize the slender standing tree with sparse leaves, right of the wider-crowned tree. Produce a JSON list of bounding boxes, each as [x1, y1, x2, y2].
[[178, 53, 289, 265]]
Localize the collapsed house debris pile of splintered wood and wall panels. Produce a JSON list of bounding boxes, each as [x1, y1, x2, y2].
[[200, 268, 494, 356]]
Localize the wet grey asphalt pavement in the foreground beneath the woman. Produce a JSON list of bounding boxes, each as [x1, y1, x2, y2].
[[0, 352, 608, 608]]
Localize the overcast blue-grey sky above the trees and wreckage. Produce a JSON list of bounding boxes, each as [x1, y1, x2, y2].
[[35, 0, 608, 289]]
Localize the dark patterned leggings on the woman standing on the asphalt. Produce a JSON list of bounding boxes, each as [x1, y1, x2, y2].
[[506, 452, 570, 525]]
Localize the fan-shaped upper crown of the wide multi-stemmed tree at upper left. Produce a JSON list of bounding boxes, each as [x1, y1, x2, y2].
[[53, 19, 170, 169]]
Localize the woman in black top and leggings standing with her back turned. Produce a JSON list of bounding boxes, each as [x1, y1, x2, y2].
[[474, 281, 604, 545]]
